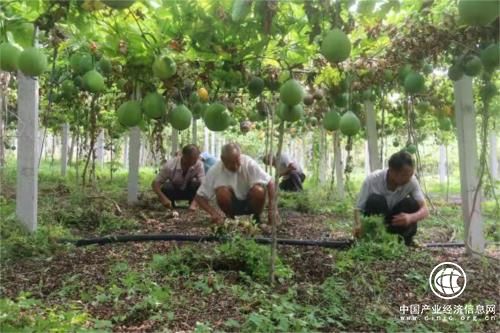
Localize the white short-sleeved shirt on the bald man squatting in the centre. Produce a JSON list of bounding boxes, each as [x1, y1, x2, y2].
[[196, 154, 271, 200]]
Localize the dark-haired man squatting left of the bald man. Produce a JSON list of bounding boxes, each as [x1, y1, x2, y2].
[[151, 144, 205, 210]]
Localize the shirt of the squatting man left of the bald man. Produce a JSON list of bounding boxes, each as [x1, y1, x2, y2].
[[155, 156, 205, 190]]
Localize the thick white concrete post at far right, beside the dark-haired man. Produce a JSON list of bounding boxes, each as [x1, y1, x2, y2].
[[453, 75, 485, 254]]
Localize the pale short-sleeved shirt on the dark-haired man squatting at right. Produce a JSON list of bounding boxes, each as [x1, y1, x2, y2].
[[357, 169, 425, 211]]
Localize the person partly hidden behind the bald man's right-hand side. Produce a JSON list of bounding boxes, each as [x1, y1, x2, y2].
[[262, 153, 306, 192]]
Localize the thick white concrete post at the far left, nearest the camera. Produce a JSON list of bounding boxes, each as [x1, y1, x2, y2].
[[16, 71, 39, 232]]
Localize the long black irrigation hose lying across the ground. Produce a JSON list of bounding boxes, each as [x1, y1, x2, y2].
[[61, 234, 464, 249]]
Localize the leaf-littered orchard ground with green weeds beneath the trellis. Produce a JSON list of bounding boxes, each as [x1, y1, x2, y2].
[[0, 159, 500, 332]]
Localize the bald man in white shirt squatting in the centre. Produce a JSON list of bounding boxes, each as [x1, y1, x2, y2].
[[195, 143, 274, 223]]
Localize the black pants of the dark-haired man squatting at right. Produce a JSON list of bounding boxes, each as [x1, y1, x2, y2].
[[363, 193, 420, 245]]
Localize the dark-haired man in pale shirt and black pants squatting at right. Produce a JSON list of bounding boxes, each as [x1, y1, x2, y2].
[[357, 151, 429, 245]]
